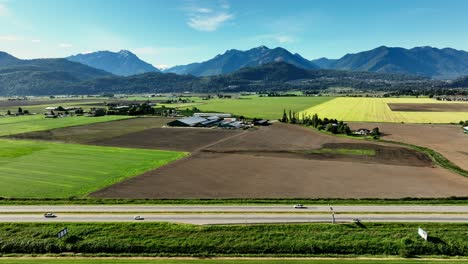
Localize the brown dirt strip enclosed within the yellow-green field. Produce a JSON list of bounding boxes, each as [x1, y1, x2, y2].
[[388, 103, 468, 112]]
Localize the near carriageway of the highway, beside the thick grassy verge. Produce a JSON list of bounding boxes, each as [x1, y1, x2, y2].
[[0, 213, 468, 224]]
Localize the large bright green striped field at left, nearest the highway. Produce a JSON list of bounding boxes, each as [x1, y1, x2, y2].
[[0, 140, 187, 198]]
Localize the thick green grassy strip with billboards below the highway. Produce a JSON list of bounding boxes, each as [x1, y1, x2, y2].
[[0, 223, 468, 257]]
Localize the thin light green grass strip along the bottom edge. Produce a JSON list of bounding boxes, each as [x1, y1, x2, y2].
[[0, 258, 468, 264]]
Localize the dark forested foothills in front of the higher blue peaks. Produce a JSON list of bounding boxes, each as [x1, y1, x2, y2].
[[0, 55, 441, 96]]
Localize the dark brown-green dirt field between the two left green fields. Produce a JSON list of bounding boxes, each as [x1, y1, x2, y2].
[[10, 117, 243, 152]]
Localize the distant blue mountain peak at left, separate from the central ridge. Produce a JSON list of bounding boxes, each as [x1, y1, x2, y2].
[[66, 50, 159, 76]]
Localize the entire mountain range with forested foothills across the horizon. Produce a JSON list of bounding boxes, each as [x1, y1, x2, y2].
[[0, 46, 468, 95]]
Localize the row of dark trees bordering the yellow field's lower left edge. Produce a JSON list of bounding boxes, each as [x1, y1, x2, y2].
[[280, 109, 352, 135]]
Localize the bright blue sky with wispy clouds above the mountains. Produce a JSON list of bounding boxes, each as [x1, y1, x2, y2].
[[0, 0, 468, 66]]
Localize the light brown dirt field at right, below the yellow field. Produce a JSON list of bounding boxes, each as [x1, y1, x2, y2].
[[350, 123, 468, 170]]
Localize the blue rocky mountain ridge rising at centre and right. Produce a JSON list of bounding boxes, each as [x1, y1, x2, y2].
[[165, 46, 468, 79]]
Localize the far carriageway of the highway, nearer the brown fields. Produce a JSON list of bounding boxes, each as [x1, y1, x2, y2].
[[0, 205, 468, 214]]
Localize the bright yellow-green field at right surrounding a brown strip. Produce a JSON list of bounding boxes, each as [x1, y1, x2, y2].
[[304, 97, 468, 123]]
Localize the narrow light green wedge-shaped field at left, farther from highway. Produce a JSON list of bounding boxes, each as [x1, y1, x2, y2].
[[0, 115, 132, 136]]
